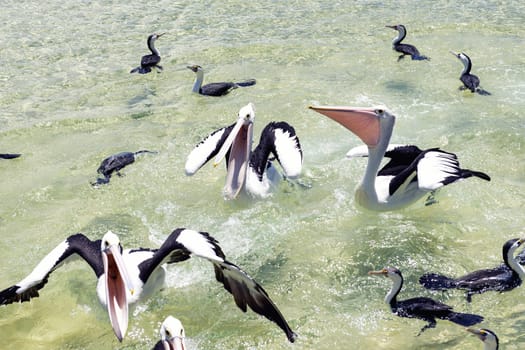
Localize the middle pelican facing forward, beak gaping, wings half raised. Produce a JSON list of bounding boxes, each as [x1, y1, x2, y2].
[[185, 103, 303, 199]]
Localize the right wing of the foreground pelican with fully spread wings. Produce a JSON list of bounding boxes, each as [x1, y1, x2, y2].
[[139, 228, 297, 342]]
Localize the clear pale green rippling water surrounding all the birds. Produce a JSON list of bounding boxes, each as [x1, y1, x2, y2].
[[0, 0, 525, 349]]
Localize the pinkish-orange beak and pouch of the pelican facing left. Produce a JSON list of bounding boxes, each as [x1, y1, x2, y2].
[[309, 106, 381, 147]]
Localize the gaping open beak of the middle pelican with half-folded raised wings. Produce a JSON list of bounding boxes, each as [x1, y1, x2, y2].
[[213, 118, 253, 199]]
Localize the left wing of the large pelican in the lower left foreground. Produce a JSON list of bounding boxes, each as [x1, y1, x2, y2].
[[0, 233, 104, 305]]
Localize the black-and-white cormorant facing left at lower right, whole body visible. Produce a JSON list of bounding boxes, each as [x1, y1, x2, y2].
[[368, 267, 483, 335]]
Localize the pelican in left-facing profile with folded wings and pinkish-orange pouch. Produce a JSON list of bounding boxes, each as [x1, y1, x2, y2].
[[310, 106, 490, 211]]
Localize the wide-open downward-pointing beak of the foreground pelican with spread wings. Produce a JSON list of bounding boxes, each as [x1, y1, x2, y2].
[[102, 245, 134, 341]]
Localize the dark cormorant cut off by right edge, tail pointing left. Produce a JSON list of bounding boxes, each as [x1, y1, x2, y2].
[[419, 238, 525, 302]]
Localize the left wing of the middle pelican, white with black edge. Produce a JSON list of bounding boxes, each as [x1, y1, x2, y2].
[[184, 124, 235, 176]]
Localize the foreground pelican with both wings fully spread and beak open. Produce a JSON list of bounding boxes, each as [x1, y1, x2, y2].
[[0, 228, 296, 342]]
